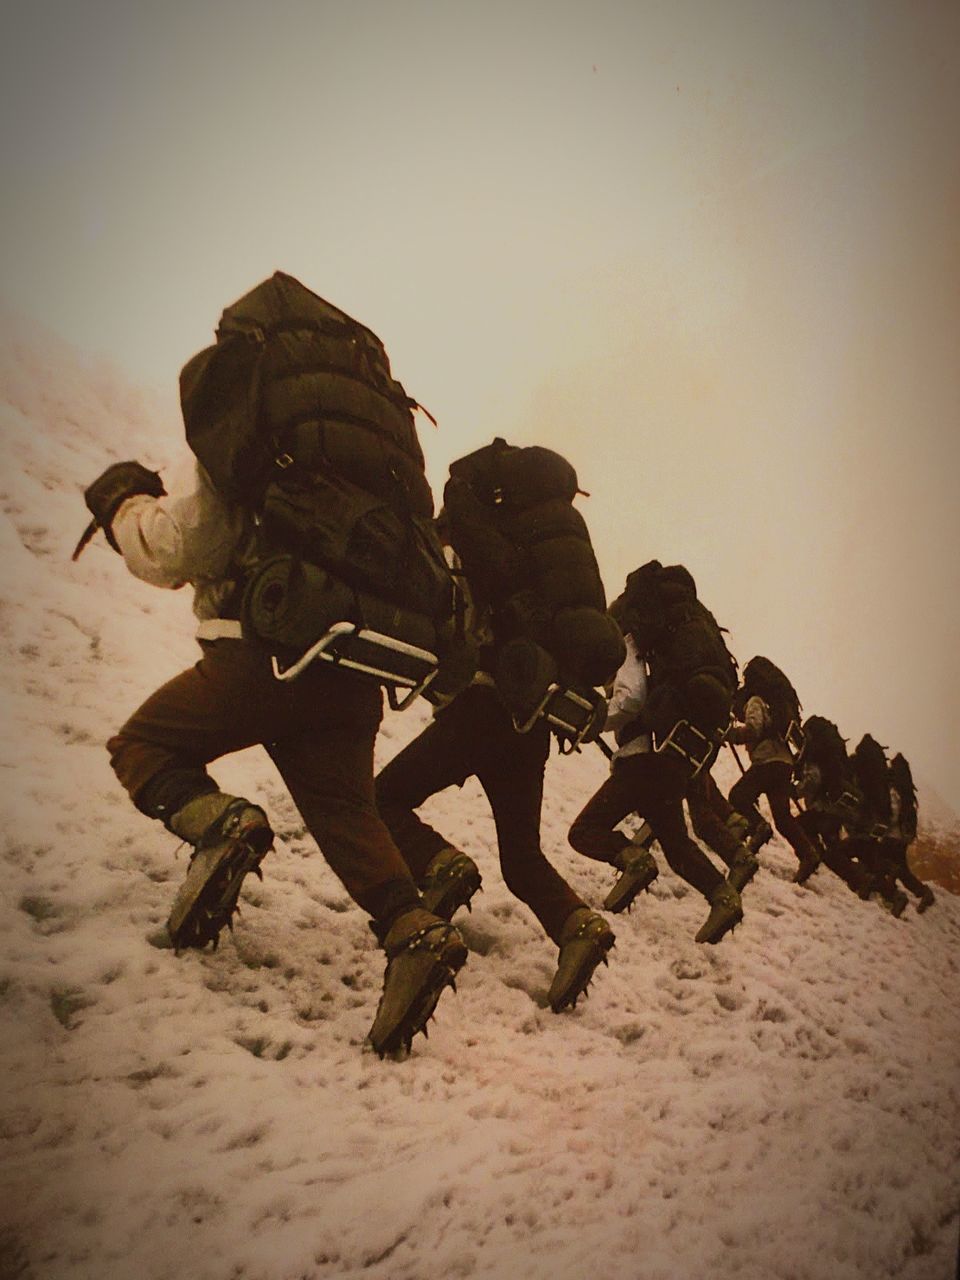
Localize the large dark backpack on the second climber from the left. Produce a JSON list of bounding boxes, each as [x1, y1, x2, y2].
[[443, 438, 626, 732]]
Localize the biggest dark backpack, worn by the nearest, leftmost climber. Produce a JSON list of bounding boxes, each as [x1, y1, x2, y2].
[[180, 271, 465, 701]]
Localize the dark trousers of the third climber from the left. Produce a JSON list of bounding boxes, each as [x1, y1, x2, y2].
[[567, 751, 723, 900]]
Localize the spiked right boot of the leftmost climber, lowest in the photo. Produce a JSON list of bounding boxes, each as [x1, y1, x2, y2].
[[367, 906, 467, 1057]]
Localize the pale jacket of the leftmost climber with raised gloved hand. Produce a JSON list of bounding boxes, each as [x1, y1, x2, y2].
[[111, 454, 252, 629]]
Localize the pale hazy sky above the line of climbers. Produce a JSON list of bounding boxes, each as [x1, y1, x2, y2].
[[0, 0, 960, 806]]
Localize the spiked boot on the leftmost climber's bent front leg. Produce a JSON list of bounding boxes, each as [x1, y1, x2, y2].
[[166, 791, 274, 951]]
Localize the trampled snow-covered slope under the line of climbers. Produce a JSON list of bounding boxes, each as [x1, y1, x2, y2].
[[0, 325, 960, 1280]]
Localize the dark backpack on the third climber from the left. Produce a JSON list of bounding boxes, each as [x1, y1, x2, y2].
[[611, 561, 737, 741]]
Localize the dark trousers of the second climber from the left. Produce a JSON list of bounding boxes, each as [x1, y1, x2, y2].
[[376, 685, 585, 945]]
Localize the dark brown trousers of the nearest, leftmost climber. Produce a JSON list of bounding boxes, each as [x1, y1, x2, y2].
[[108, 640, 417, 919]]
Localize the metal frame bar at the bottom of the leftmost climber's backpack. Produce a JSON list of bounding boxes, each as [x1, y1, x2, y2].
[[273, 622, 436, 710]]
